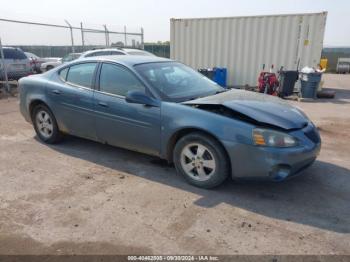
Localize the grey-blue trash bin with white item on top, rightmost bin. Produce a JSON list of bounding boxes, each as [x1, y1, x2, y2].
[[300, 73, 322, 98]]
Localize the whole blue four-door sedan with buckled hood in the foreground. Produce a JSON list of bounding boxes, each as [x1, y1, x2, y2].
[[19, 55, 321, 188]]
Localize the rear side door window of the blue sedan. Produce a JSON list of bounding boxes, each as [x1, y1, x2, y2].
[[65, 63, 97, 88]]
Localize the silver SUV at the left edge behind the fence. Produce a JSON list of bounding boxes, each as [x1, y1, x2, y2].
[[0, 47, 33, 80]]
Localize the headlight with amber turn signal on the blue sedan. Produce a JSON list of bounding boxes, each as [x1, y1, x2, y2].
[[253, 128, 298, 147]]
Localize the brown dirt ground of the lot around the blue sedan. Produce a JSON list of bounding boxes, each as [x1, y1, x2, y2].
[[0, 75, 350, 254]]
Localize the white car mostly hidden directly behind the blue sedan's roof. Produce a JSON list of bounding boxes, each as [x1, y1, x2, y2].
[[79, 48, 155, 58]]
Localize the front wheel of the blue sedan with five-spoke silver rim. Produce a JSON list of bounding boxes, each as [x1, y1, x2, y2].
[[173, 132, 230, 188]]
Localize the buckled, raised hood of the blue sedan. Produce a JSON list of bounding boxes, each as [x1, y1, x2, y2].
[[183, 90, 309, 130]]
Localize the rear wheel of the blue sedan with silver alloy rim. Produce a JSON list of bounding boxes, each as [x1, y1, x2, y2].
[[32, 104, 62, 144]]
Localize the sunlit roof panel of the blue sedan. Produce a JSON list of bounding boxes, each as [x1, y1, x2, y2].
[[79, 55, 173, 66]]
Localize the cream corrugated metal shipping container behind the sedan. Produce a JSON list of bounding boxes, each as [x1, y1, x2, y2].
[[170, 12, 327, 86]]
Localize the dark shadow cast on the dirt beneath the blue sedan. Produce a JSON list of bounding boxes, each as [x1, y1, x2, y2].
[[50, 137, 350, 233]]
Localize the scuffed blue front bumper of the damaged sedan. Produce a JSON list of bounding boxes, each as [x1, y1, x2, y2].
[[224, 123, 321, 181]]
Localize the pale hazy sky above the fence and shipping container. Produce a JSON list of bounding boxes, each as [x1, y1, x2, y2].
[[0, 0, 350, 46]]
